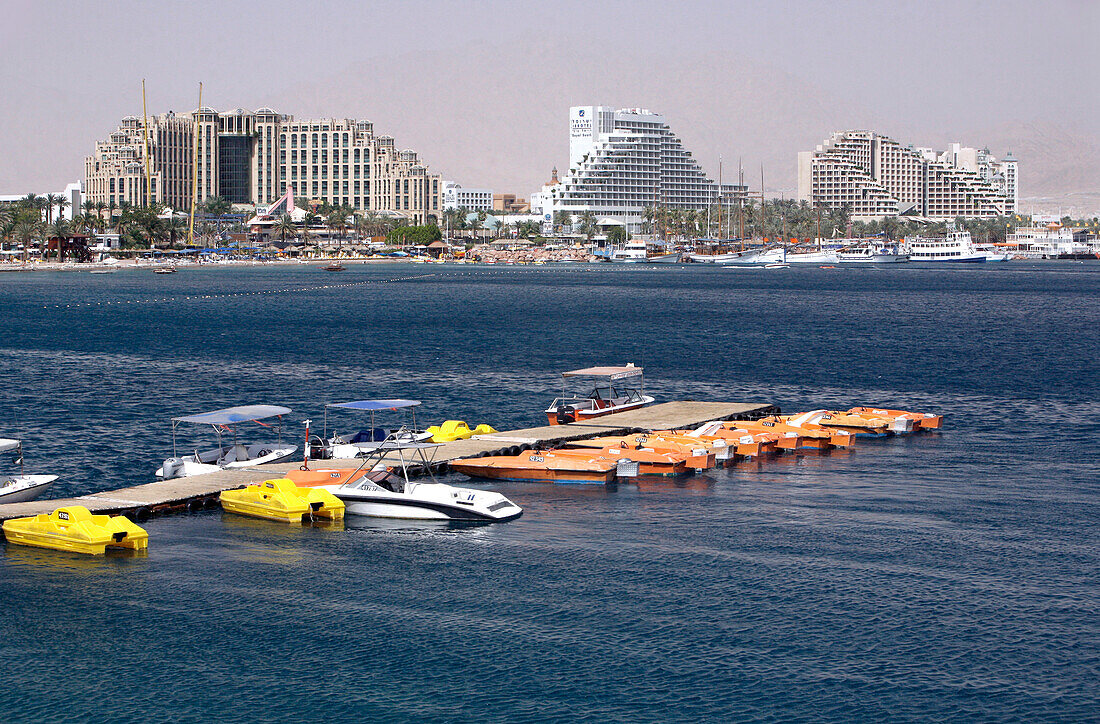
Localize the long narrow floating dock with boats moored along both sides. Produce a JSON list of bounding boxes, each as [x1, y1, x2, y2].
[[0, 402, 780, 522]]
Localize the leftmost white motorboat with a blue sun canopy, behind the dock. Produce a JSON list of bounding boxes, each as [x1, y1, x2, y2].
[[156, 405, 298, 480]]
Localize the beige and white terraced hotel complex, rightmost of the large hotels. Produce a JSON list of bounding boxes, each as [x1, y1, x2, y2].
[[799, 131, 1020, 221]]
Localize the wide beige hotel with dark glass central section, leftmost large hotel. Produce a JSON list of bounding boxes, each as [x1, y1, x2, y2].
[[85, 108, 443, 223]]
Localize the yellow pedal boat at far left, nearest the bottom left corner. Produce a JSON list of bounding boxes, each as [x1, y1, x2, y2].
[[3, 505, 149, 556]]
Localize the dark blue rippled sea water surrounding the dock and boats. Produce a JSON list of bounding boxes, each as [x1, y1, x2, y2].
[[0, 262, 1100, 722]]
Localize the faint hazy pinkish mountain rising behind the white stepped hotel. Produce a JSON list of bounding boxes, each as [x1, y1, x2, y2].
[[272, 42, 1100, 209]]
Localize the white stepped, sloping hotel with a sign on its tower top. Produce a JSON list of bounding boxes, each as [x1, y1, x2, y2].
[[531, 106, 746, 231]]
